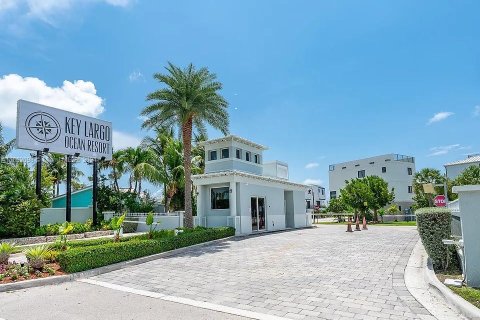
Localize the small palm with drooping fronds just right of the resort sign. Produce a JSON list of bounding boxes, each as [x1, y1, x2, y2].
[[119, 146, 158, 194]]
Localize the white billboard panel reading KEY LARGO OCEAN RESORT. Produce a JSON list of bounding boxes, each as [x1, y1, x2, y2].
[[16, 100, 112, 160]]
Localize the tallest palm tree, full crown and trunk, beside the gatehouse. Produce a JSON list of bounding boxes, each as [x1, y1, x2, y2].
[[141, 63, 229, 228]]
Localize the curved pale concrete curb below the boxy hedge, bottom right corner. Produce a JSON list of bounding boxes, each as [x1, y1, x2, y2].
[[424, 258, 480, 320]]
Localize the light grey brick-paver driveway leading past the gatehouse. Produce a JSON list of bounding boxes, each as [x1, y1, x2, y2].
[[87, 226, 433, 319]]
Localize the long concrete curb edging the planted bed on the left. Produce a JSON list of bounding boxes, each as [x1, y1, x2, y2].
[[0, 236, 235, 292]]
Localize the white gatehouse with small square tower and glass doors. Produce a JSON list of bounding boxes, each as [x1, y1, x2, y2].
[[192, 135, 311, 234]]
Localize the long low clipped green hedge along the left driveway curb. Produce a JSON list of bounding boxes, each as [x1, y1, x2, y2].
[[57, 227, 235, 273]]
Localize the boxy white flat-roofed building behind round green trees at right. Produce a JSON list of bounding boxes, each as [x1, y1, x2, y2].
[[329, 153, 415, 211]]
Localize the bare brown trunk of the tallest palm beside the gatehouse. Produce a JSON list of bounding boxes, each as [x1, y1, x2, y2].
[[182, 117, 193, 228]]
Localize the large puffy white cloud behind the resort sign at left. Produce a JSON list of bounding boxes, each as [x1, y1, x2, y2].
[[0, 74, 104, 128]]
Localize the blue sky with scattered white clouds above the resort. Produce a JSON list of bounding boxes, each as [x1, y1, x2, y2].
[[0, 0, 480, 196]]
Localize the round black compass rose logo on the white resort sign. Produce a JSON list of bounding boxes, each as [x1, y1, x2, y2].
[[25, 112, 61, 143]]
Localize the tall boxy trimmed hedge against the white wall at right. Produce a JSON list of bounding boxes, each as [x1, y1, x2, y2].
[[415, 207, 452, 270]]
